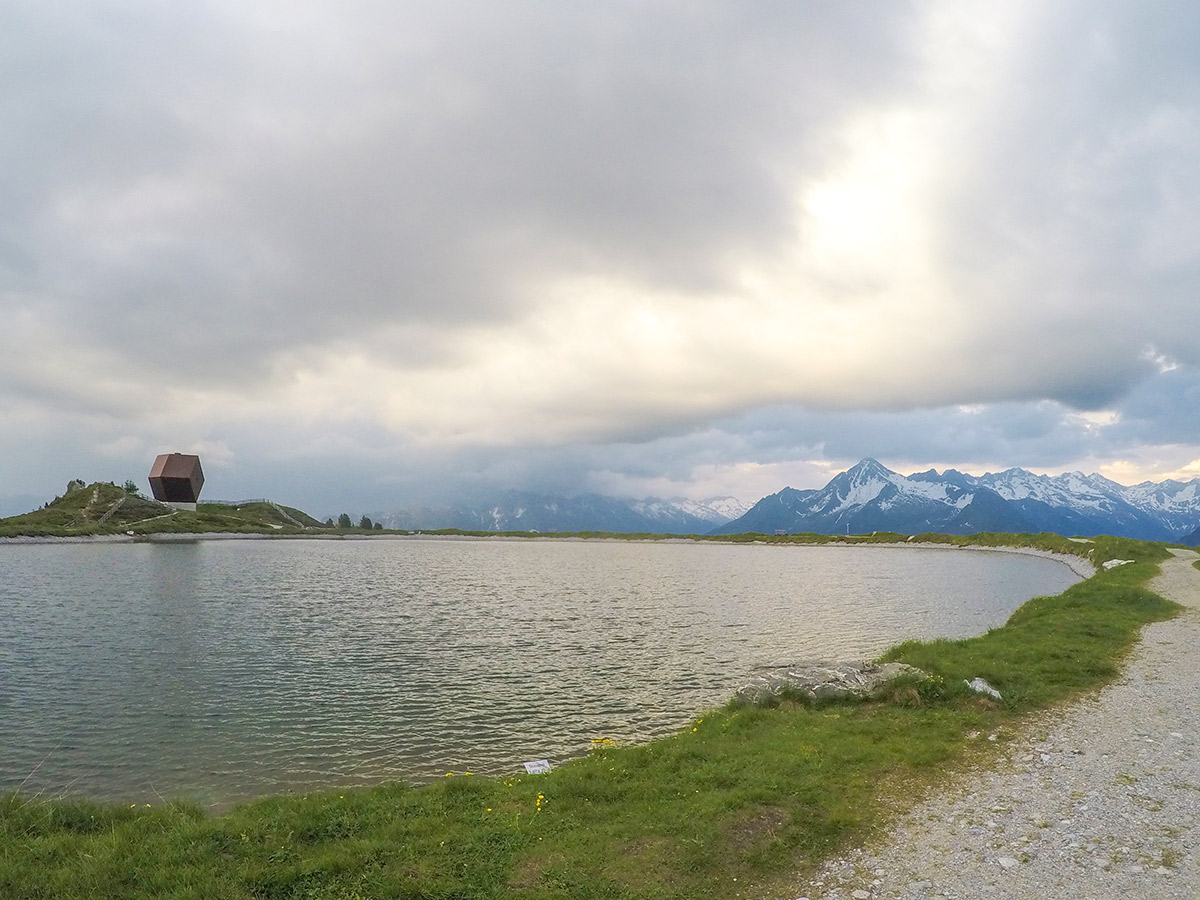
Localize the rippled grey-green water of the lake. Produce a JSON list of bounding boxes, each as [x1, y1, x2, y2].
[[0, 540, 1078, 805]]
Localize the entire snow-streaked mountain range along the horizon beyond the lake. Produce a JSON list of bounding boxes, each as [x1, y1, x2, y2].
[[377, 458, 1200, 545]]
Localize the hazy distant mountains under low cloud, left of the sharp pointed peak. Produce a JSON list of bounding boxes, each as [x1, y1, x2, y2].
[[378, 491, 749, 534]]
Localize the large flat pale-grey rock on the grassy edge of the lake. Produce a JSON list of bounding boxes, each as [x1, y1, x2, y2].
[[736, 660, 928, 703]]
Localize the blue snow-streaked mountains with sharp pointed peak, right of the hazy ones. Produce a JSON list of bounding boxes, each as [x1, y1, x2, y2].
[[714, 460, 1200, 540]]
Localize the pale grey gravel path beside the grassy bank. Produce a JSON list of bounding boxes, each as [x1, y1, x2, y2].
[[788, 551, 1200, 900]]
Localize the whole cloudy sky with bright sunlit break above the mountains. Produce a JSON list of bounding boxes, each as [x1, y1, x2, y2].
[[0, 0, 1200, 516]]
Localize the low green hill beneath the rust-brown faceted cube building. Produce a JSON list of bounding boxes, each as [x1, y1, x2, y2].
[[0, 482, 326, 538]]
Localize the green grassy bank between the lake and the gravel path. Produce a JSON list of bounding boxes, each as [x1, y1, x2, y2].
[[0, 536, 1176, 900]]
